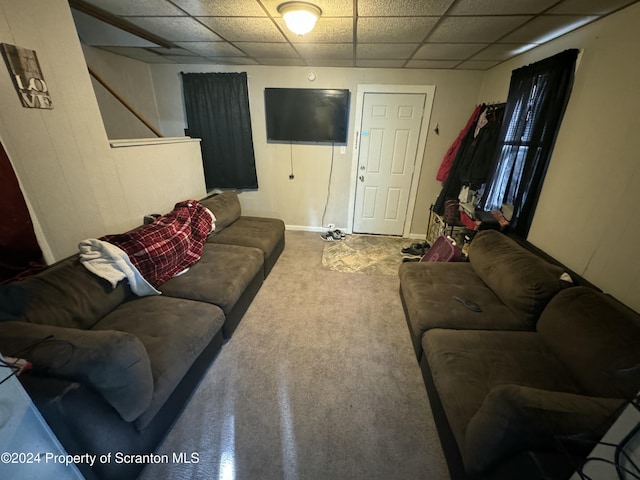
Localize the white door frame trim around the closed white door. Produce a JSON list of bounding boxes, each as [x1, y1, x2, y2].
[[347, 84, 436, 237]]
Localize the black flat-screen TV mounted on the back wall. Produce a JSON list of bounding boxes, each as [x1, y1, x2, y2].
[[264, 88, 350, 143]]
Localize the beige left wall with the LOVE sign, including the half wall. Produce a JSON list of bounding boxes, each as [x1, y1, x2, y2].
[[0, 0, 204, 262]]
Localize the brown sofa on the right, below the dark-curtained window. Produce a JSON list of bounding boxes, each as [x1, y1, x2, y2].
[[399, 231, 640, 480]]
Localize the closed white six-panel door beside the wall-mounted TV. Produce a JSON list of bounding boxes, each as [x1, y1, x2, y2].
[[353, 93, 426, 235]]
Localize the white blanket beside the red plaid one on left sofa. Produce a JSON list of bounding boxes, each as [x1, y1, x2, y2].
[[78, 238, 160, 297]]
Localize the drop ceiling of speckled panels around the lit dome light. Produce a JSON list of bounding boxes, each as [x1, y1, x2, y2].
[[69, 0, 639, 70]]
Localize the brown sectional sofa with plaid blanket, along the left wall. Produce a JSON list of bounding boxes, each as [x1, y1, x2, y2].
[[0, 191, 284, 479]]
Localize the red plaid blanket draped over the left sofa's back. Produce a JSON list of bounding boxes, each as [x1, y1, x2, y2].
[[100, 200, 213, 287]]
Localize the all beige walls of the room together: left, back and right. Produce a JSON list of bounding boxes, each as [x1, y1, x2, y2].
[[0, 0, 640, 310]]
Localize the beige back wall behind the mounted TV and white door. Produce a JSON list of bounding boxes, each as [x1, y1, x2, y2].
[[151, 65, 482, 238]]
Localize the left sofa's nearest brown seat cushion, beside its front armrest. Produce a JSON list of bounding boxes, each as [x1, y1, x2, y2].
[[93, 296, 224, 430]]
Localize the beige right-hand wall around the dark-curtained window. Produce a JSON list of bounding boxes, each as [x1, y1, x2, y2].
[[482, 4, 640, 311]]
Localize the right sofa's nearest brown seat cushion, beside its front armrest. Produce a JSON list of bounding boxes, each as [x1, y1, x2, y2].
[[422, 329, 580, 458]]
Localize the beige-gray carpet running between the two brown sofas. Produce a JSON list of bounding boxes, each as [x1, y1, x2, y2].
[[142, 231, 449, 480]]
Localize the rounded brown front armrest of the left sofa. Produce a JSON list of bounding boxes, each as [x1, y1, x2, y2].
[[0, 321, 153, 421]]
